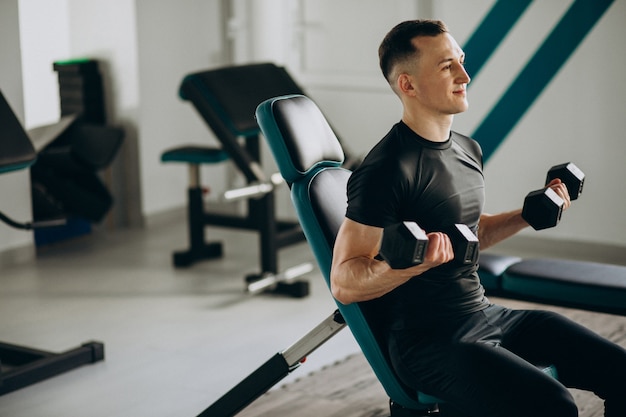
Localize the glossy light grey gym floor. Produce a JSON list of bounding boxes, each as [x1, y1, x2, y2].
[[0, 213, 624, 417]]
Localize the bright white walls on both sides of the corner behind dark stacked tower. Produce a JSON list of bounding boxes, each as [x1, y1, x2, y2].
[[19, 0, 142, 226]]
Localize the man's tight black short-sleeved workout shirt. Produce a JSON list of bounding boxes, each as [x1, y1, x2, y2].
[[346, 122, 488, 330]]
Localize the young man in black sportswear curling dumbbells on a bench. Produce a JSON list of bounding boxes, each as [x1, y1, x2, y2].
[[331, 20, 626, 417]]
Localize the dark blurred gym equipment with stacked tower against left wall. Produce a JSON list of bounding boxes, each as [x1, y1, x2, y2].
[[28, 59, 125, 246]]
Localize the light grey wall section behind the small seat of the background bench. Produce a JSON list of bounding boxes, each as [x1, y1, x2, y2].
[[136, 0, 227, 216]]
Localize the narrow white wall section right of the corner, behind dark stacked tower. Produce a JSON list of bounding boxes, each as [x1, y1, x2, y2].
[[66, 0, 143, 227]]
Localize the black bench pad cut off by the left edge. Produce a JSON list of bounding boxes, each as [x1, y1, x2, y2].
[[0, 91, 37, 172]]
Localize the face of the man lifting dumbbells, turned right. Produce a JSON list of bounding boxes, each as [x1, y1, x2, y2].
[[404, 33, 470, 115]]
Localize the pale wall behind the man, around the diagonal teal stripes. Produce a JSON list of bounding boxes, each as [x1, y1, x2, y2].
[[266, 0, 626, 246]]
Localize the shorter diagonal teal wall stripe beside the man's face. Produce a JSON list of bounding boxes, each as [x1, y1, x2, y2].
[[463, 0, 532, 77]]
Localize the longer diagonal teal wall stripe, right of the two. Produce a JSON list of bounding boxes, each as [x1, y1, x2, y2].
[[472, 0, 614, 161]]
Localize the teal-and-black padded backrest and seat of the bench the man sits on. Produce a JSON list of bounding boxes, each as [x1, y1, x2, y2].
[[246, 95, 554, 417]]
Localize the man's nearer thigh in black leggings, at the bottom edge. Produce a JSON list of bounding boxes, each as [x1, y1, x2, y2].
[[392, 334, 575, 417]]
